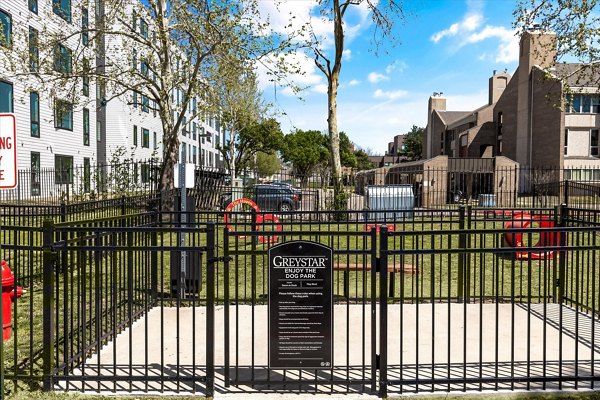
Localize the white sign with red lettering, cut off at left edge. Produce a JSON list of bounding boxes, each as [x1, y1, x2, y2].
[[0, 114, 17, 189]]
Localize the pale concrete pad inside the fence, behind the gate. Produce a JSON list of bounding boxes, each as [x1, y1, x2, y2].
[[58, 303, 600, 398]]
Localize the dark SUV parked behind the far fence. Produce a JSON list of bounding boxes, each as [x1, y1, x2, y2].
[[220, 184, 301, 211]]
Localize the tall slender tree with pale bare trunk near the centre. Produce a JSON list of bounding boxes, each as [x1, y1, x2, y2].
[[311, 0, 404, 210]]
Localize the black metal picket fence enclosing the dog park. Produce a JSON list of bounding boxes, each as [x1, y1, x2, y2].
[[1, 206, 600, 396]]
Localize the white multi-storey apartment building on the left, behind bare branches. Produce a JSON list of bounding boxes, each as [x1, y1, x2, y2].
[[0, 0, 225, 197]]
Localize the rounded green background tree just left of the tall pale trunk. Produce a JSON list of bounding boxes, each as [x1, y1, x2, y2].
[[281, 130, 330, 184]]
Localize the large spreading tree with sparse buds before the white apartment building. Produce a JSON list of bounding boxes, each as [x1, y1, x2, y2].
[[0, 0, 289, 199]]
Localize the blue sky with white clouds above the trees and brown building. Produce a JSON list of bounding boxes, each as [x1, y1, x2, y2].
[[260, 0, 518, 154]]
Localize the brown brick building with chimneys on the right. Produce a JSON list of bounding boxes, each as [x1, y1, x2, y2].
[[423, 29, 600, 172]]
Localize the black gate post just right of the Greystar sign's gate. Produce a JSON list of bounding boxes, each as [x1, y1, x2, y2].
[[379, 225, 388, 398]]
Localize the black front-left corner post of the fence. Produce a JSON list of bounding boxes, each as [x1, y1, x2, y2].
[[42, 219, 56, 391]]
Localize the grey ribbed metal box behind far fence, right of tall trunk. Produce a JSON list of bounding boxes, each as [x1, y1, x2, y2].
[[365, 185, 415, 222]]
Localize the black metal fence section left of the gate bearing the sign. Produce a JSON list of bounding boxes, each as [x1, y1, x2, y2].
[[44, 221, 215, 395]]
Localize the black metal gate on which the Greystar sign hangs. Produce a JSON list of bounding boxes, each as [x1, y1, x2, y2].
[[216, 222, 378, 393]]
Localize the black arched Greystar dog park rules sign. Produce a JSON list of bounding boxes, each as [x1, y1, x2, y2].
[[269, 240, 333, 369]]
